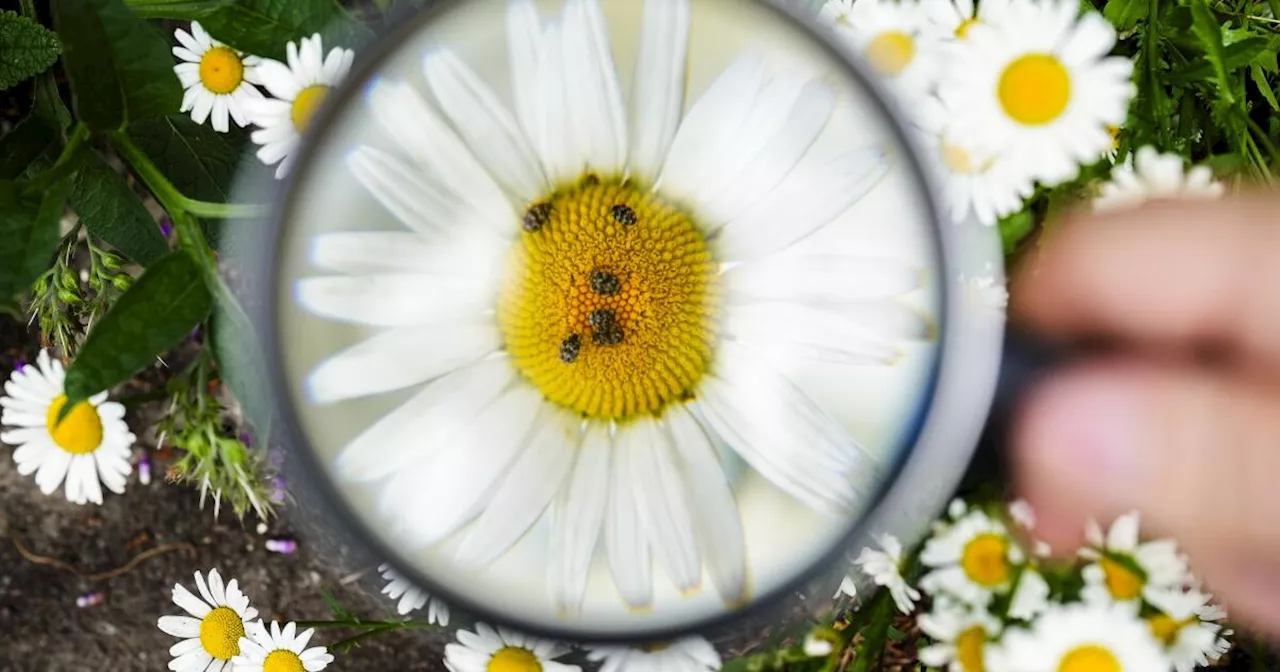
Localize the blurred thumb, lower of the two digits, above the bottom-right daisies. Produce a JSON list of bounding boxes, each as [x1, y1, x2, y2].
[[1012, 360, 1280, 632]]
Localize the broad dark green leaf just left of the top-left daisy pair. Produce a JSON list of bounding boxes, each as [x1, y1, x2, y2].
[[54, 0, 182, 131]]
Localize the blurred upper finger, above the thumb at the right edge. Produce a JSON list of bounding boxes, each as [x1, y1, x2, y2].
[[1011, 197, 1280, 365]]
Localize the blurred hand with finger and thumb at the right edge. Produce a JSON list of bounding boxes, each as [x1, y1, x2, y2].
[[1010, 197, 1280, 636]]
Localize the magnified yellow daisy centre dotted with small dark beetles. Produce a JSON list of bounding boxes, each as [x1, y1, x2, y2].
[[498, 175, 717, 419]]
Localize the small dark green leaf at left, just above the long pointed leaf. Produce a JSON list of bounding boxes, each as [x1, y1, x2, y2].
[[72, 154, 169, 266]]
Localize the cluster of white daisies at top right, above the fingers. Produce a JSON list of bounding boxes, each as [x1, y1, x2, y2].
[[822, 0, 1222, 225]]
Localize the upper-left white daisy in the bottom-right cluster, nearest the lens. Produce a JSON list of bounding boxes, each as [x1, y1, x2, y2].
[[920, 509, 1024, 607]]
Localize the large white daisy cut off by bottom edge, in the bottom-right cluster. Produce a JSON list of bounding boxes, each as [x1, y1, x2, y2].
[[992, 603, 1169, 672]]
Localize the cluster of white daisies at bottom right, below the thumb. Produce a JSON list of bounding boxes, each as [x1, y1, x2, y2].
[[837, 500, 1231, 672]]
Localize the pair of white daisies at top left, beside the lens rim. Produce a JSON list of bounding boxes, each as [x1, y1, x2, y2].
[[173, 22, 355, 178]]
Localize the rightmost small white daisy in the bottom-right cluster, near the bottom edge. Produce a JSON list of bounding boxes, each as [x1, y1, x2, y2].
[[1147, 589, 1225, 672]]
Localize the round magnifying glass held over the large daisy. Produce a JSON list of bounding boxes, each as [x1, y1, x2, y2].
[[232, 0, 1004, 641]]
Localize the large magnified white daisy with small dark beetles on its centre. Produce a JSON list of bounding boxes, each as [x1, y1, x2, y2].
[[297, 0, 932, 612]]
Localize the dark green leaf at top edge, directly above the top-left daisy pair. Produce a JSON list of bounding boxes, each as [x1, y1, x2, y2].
[[200, 0, 374, 60]]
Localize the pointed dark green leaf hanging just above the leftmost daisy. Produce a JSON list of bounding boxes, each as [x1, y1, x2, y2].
[[65, 250, 211, 408]]
